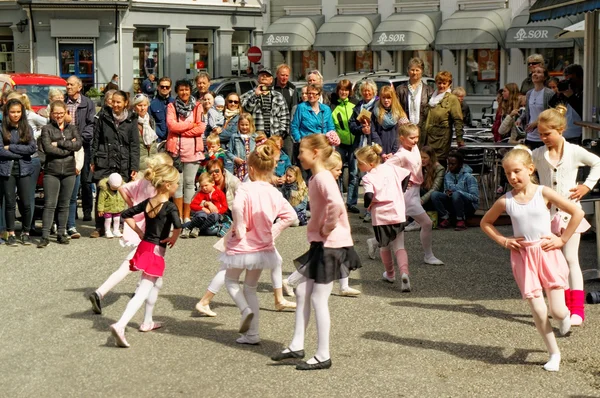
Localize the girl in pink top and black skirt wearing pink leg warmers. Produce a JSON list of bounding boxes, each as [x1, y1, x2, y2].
[[356, 144, 410, 292]]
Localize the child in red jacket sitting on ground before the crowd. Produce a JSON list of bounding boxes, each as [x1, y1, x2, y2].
[[182, 173, 231, 237]]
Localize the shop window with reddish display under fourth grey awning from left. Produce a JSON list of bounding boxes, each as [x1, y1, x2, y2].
[[466, 49, 500, 95]]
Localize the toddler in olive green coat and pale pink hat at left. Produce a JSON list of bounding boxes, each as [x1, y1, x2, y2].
[[98, 173, 126, 239]]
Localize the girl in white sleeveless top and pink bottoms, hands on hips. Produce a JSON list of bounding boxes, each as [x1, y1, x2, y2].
[[481, 145, 583, 372]]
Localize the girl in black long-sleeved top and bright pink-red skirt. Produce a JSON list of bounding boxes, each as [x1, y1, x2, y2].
[[110, 165, 181, 348]]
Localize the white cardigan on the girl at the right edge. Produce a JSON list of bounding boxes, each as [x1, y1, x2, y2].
[[532, 140, 600, 216]]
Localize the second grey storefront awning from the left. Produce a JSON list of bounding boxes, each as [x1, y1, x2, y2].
[[313, 14, 381, 51]]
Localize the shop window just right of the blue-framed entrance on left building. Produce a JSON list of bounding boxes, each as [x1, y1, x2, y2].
[[133, 28, 165, 91]]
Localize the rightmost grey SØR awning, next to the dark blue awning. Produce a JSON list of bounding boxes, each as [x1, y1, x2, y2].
[[506, 10, 583, 48]]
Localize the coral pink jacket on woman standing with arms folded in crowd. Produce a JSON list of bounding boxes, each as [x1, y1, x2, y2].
[[167, 102, 206, 163]]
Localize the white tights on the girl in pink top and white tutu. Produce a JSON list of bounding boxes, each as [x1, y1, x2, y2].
[[225, 268, 262, 336]]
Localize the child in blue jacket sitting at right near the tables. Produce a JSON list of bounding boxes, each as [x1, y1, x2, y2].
[[431, 151, 479, 231]]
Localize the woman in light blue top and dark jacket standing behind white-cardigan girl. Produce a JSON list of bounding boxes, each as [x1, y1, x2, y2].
[[516, 64, 557, 150]]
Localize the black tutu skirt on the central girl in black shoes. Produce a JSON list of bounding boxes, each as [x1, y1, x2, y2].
[[294, 242, 362, 283]]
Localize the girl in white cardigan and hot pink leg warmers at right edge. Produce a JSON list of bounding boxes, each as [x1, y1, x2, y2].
[[533, 105, 600, 326]]
